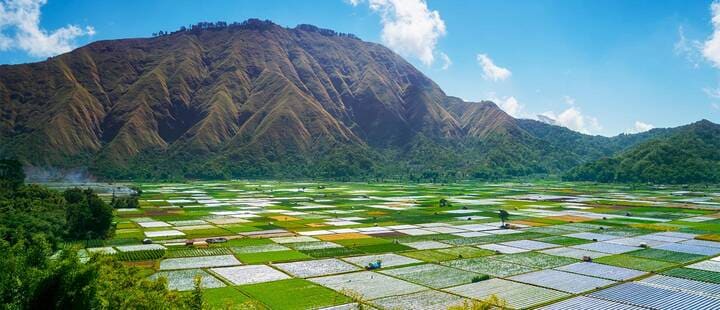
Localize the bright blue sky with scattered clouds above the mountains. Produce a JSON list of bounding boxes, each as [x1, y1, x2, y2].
[[0, 0, 720, 135]]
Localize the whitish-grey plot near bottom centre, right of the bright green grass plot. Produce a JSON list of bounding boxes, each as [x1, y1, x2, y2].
[[310, 271, 426, 299]]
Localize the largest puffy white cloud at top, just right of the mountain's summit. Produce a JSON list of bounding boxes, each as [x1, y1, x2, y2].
[[349, 0, 446, 66]]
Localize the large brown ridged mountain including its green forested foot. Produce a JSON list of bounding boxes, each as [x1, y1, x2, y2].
[[0, 19, 692, 179]]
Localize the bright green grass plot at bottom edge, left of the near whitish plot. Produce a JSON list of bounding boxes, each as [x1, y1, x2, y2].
[[238, 279, 350, 310]]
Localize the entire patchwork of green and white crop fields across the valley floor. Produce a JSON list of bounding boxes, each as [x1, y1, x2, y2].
[[74, 181, 720, 309]]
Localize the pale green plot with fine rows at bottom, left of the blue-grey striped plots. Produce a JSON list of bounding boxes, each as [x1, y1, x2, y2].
[[446, 279, 569, 309]]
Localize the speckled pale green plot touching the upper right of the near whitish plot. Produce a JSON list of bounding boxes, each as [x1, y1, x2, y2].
[[381, 264, 483, 288]]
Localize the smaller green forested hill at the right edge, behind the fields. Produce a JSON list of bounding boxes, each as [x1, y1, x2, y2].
[[565, 120, 720, 183]]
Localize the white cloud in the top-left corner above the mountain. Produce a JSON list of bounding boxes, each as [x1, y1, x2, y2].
[[0, 0, 95, 57]]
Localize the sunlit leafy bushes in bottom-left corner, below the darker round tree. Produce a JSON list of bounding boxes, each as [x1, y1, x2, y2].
[[0, 239, 202, 309]]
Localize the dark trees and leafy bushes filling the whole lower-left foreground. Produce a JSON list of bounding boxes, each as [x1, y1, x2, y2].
[[0, 174, 203, 309]]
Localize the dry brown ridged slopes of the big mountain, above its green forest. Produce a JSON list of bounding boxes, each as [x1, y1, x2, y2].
[[0, 22, 519, 172]]
